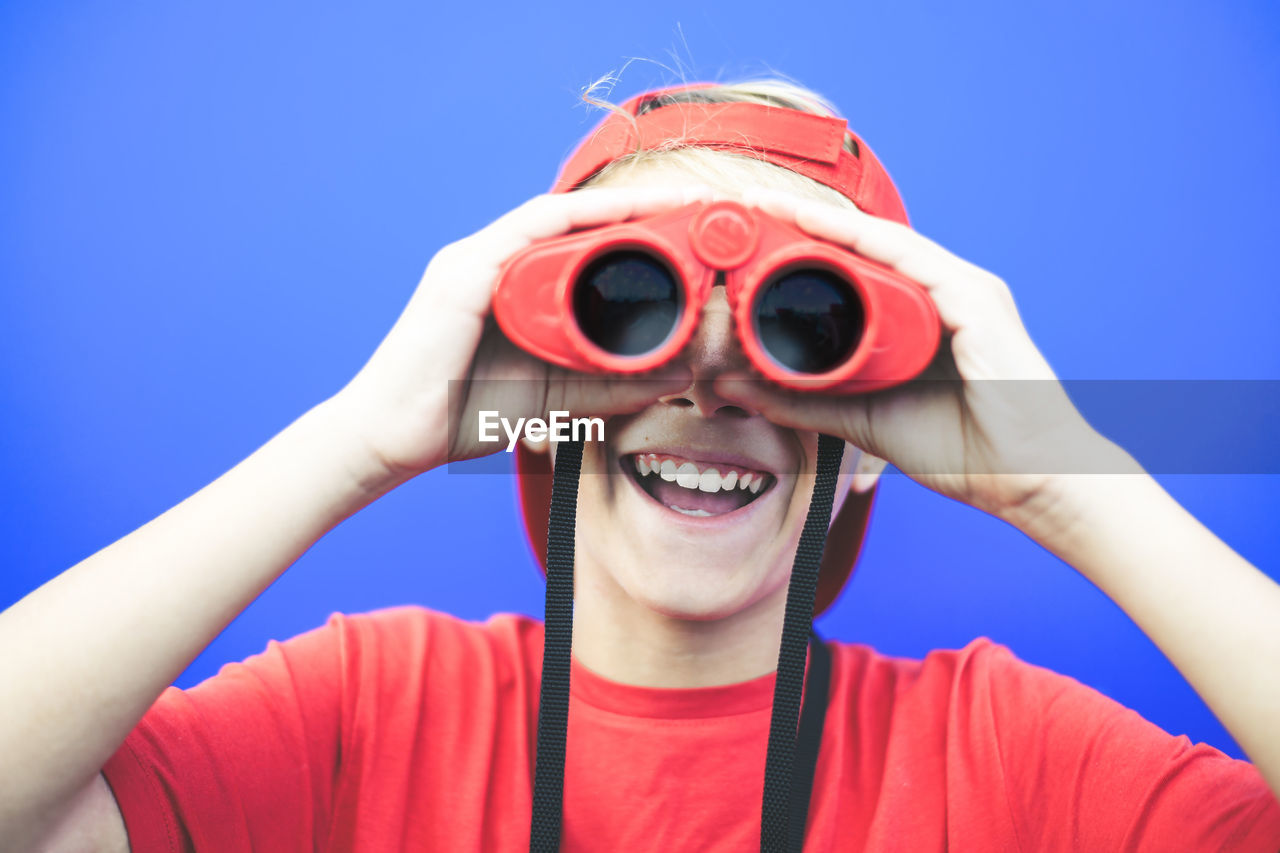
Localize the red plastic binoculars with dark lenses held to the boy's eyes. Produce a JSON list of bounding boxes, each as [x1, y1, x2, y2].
[[493, 201, 941, 393]]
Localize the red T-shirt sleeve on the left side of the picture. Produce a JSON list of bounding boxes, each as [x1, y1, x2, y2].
[[102, 613, 355, 853]]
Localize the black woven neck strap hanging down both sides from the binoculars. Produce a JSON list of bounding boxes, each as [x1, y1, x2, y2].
[[529, 435, 845, 853]]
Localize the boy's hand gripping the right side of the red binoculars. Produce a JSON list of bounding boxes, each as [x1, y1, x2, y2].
[[717, 190, 1110, 524]]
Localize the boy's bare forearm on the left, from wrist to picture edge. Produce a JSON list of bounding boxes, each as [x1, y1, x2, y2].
[[0, 394, 396, 839]]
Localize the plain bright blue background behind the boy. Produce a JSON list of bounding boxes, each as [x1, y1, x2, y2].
[[0, 1, 1280, 754]]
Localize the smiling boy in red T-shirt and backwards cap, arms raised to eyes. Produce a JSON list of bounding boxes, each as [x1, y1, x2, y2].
[[0, 83, 1280, 850]]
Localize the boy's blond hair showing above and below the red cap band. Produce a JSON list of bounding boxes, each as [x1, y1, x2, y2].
[[582, 77, 859, 207]]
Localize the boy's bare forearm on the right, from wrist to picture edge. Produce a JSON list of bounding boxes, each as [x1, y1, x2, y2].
[[1015, 451, 1280, 797]]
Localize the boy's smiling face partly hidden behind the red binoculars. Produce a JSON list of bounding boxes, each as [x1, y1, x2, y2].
[[540, 159, 880, 620]]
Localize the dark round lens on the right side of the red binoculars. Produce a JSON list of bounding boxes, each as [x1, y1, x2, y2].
[[755, 269, 867, 373]]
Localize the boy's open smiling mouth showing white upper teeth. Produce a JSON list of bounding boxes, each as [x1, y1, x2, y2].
[[618, 453, 777, 517]]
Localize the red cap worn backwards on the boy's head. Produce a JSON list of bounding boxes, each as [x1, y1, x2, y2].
[[516, 83, 909, 615]]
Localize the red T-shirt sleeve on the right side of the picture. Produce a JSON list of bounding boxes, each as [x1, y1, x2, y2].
[[965, 644, 1280, 853]]
